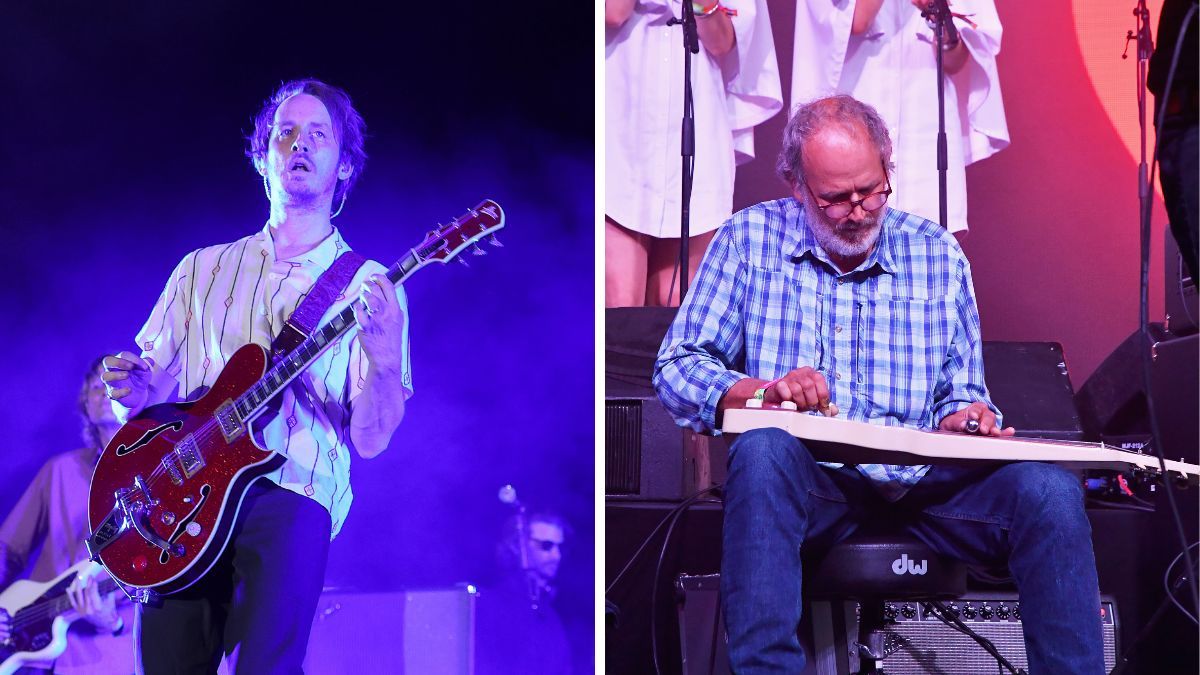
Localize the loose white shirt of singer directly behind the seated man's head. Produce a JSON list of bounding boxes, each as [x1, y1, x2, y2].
[[792, 0, 1008, 232]]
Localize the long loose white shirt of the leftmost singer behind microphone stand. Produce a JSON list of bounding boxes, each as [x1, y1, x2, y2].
[[605, 0, 784, 238]]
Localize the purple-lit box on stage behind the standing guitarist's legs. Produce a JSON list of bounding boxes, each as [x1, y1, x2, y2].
[[304, 585, 476, 675]]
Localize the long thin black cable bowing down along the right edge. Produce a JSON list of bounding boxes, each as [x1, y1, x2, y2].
[[1139, 2, 1200, 616]]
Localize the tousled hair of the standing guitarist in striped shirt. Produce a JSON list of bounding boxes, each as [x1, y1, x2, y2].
[[246, 79, 367, 210]]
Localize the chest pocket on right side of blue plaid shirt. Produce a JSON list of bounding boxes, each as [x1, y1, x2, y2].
[[857, 297, 954, 426]]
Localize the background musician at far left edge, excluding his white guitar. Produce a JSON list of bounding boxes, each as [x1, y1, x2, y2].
[[0, 358, 133, 674]]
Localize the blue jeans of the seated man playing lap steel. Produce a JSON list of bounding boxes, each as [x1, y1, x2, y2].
[[721, 429, 1104, 675]]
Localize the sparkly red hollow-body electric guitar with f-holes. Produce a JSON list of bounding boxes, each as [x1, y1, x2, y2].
[[86, 201, 504, 593]]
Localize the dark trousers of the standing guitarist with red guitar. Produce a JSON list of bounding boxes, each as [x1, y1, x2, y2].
[[137, 479, 331, 675]]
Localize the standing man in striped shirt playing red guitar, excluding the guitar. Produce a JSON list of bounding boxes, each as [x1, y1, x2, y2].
[[103, 80, 413, 673]]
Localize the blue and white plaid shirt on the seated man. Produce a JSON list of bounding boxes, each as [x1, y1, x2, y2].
[[654, 198, 998, 501]]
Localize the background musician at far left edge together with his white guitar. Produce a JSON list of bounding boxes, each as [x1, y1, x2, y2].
[[0, 358, 133, 674]]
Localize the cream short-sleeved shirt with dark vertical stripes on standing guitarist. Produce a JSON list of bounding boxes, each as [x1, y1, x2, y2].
[[137, 227, 413, 538]]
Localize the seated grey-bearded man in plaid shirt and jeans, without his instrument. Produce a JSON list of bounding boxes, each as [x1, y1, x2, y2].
[[654, 96, 1104, 674]]
